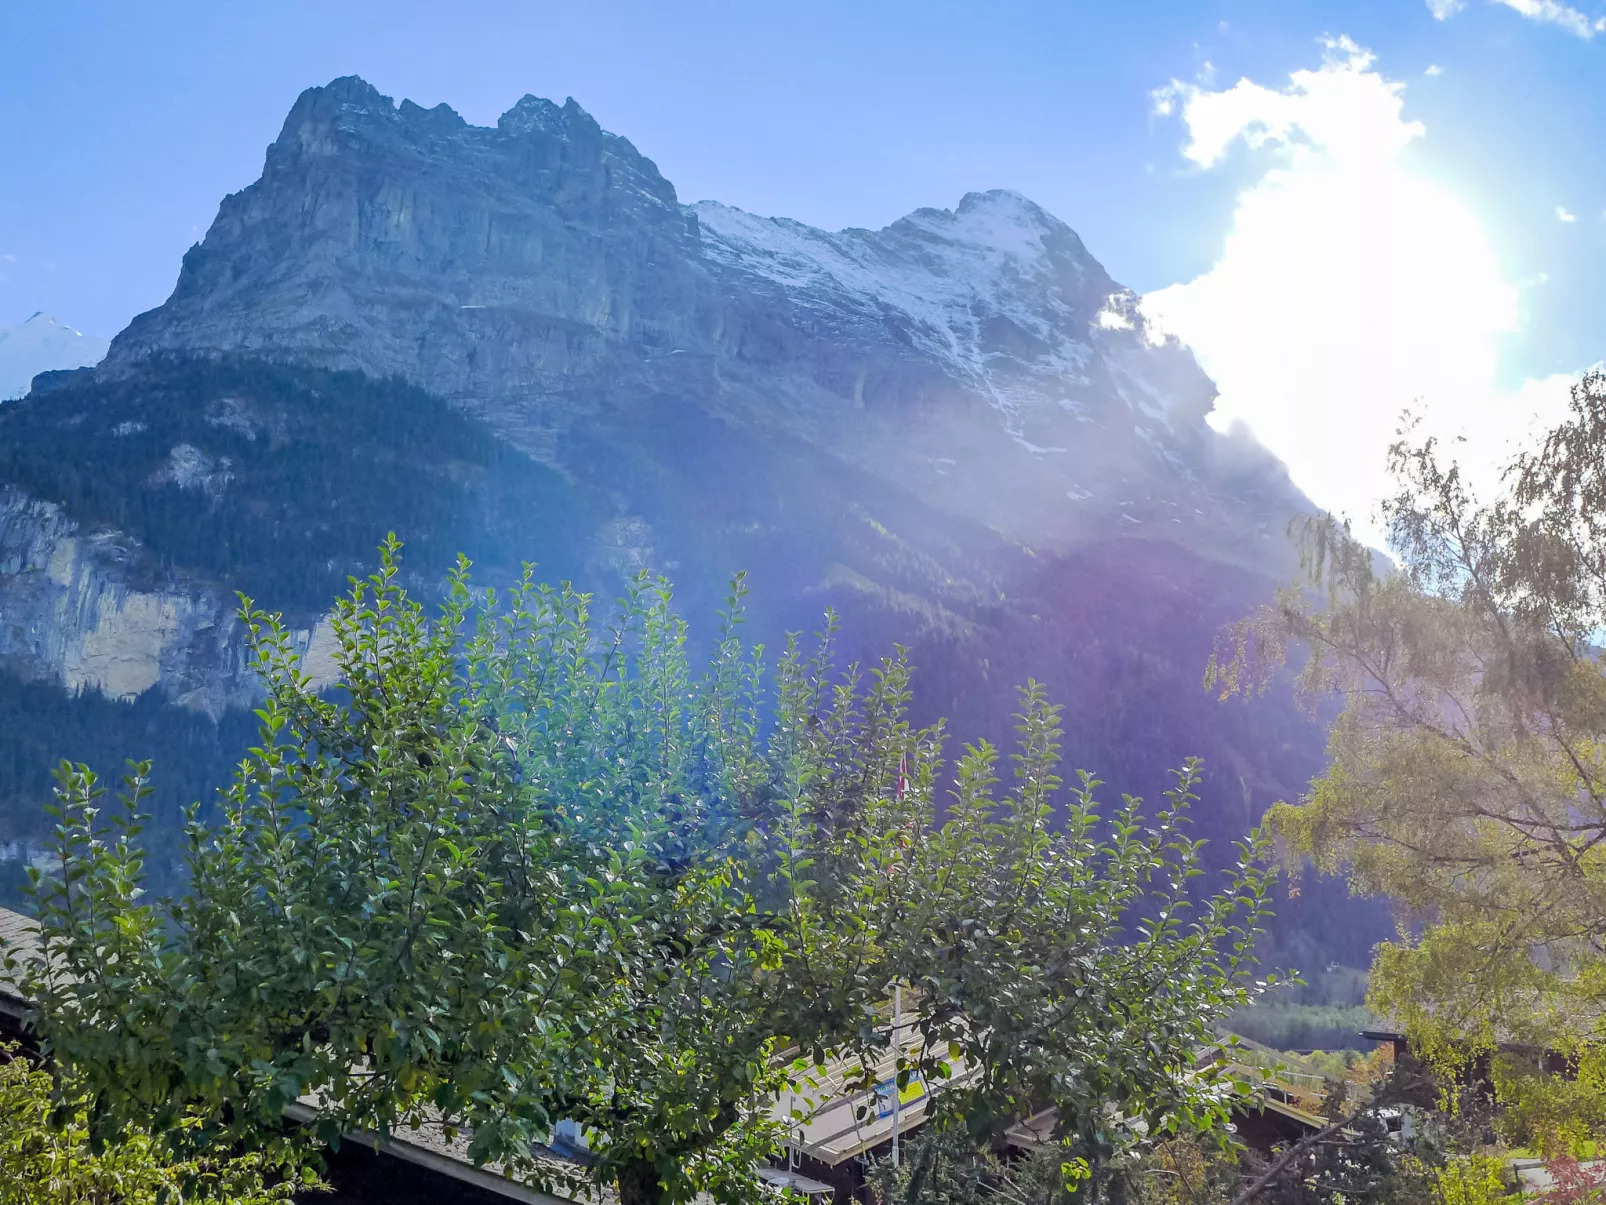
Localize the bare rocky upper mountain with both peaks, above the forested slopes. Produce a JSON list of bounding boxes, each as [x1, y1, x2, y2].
[[103, 79, 1302, 566]]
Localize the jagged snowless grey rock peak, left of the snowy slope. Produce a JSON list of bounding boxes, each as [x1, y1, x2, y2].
[[114, 79, 699, 453]]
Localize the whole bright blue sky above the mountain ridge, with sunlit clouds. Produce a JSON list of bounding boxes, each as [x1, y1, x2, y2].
[[0, 0, 1606, 523]]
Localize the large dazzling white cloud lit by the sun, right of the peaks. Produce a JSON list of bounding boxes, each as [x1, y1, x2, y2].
[[1142, 39, 1566, 537]]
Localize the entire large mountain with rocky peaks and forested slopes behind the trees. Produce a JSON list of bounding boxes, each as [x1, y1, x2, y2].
[[0, 77, 1370, 948]]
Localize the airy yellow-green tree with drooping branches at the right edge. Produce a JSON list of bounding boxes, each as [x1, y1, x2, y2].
[[1208, 373, 1606, 1092]]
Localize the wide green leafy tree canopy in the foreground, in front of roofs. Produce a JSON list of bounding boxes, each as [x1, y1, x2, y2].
[[18, 541, 1269, 1202]]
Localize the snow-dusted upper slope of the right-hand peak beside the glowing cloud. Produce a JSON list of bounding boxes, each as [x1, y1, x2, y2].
[[691, 190, 1302, 561]]
